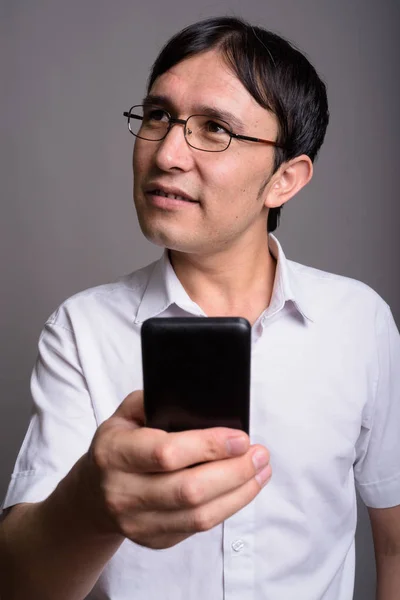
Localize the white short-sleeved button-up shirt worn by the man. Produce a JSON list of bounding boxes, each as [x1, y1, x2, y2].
[[4, 236, 400, 600]]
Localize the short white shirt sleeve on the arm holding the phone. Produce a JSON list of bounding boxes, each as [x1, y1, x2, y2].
[[2, 319, 97, 509]]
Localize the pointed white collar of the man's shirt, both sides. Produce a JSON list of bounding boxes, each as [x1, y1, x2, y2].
[[135, 234, 312, 323]]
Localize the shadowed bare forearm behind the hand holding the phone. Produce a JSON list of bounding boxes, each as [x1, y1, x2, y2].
[[0, 457, 123, 600]]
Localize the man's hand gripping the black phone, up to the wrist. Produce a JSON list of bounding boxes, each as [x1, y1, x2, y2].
[[87, 391, 271, 548]]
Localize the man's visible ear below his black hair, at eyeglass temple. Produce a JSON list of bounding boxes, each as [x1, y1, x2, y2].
[[264, 154, 313, 208]]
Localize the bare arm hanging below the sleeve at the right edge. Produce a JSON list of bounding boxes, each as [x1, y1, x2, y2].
[[368, 506, 400, 600]]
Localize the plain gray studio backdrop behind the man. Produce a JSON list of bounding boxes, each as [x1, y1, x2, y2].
[[0, 0, 400, 600]]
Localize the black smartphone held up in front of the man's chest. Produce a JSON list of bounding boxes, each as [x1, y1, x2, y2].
[[141, 317, 251, 433]]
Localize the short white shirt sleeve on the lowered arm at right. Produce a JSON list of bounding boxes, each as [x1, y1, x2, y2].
[[354, 304, 400, 508]]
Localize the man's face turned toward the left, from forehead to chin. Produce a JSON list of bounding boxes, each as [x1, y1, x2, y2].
[[133, 51, 278, 254]]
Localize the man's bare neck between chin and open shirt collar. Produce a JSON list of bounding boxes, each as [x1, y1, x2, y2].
[[169, 236, 276, 324]]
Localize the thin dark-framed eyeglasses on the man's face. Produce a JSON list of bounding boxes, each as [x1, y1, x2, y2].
[[124, 104, 283, 152]]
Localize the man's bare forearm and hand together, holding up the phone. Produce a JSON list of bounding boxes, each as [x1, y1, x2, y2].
[[0, 392, 271, 600]]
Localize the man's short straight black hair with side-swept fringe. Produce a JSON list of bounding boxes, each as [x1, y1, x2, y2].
[[147, 17, 329, 231]]
